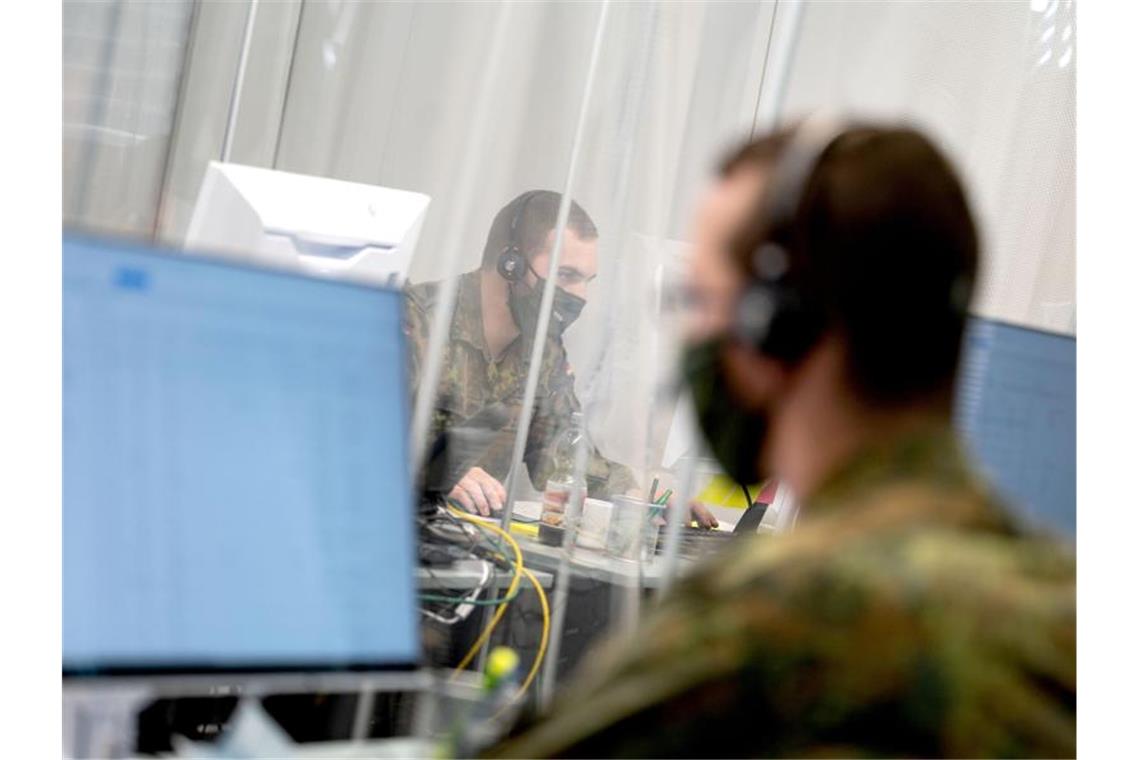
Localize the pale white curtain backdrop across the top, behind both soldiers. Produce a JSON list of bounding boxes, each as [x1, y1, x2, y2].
[[64, 0, 1076, 476]]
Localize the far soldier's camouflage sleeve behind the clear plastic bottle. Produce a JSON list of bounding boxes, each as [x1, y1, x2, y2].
[[524, 342, 637, 498]]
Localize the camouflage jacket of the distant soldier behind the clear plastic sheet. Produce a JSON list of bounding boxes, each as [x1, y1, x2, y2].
[[405, 270, 636, 497]]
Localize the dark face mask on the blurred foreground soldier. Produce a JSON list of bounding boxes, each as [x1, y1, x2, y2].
[[682, 336, 768, 485]]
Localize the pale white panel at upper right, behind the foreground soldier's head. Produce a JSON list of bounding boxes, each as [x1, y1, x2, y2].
[[785, 0, 1076, 333]]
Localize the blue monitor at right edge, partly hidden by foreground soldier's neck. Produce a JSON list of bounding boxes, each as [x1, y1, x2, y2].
[[955, 318, 1076, 539]]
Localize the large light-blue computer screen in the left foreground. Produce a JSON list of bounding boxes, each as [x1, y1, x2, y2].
[[63, 237, 420, 672]]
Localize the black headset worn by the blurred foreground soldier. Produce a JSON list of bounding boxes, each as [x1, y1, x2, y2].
[[734, 116, 849, 362]]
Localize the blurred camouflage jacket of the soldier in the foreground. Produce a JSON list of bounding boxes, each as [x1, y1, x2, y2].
[[492, 431, 1076, 758]]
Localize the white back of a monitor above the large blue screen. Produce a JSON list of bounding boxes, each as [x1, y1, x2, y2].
[[186, 161, 431, 286]]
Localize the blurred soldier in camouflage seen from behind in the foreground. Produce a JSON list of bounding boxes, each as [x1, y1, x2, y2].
[[491, 122, 1076, 758]]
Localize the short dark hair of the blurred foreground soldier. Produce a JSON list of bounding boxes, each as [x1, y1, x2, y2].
[[720, 125, 980, 408]]
